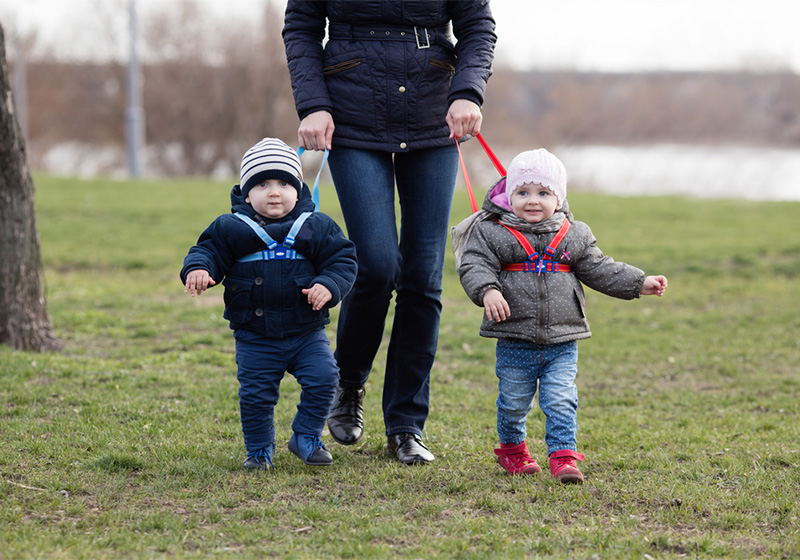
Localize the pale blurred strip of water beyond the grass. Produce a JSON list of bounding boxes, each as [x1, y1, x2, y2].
[[38, 141, 800, 201]]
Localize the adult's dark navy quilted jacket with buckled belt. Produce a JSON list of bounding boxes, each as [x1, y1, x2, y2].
[[283, 0, 497, 152]]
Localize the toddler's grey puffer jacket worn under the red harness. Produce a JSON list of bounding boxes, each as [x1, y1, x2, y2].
[[458, 180, 645, 345]]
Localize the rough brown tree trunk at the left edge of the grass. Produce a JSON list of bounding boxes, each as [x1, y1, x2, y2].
[[0, 25, 61, 352]]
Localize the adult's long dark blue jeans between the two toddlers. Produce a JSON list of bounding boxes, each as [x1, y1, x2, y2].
[[328, 145, 458, 435]]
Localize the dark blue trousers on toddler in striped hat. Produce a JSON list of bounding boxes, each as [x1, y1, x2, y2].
[[234, 329, 339, 453]]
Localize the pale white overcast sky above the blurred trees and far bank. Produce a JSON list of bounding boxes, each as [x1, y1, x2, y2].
[[0, 0, 800, 73]]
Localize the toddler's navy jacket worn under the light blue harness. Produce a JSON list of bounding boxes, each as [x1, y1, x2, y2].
[[181, 184, 357, 338]]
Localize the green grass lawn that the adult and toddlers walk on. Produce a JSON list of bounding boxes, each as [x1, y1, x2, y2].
[[0, 173, 800, 559]]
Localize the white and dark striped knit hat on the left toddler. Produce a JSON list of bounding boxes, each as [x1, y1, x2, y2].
[[240, 138, 303, 196]]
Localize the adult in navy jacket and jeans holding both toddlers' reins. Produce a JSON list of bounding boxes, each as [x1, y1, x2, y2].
[[283, 0, 496, 464]]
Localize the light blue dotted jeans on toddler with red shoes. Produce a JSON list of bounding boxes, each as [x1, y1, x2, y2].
[[496, 339, 578, 455]]
